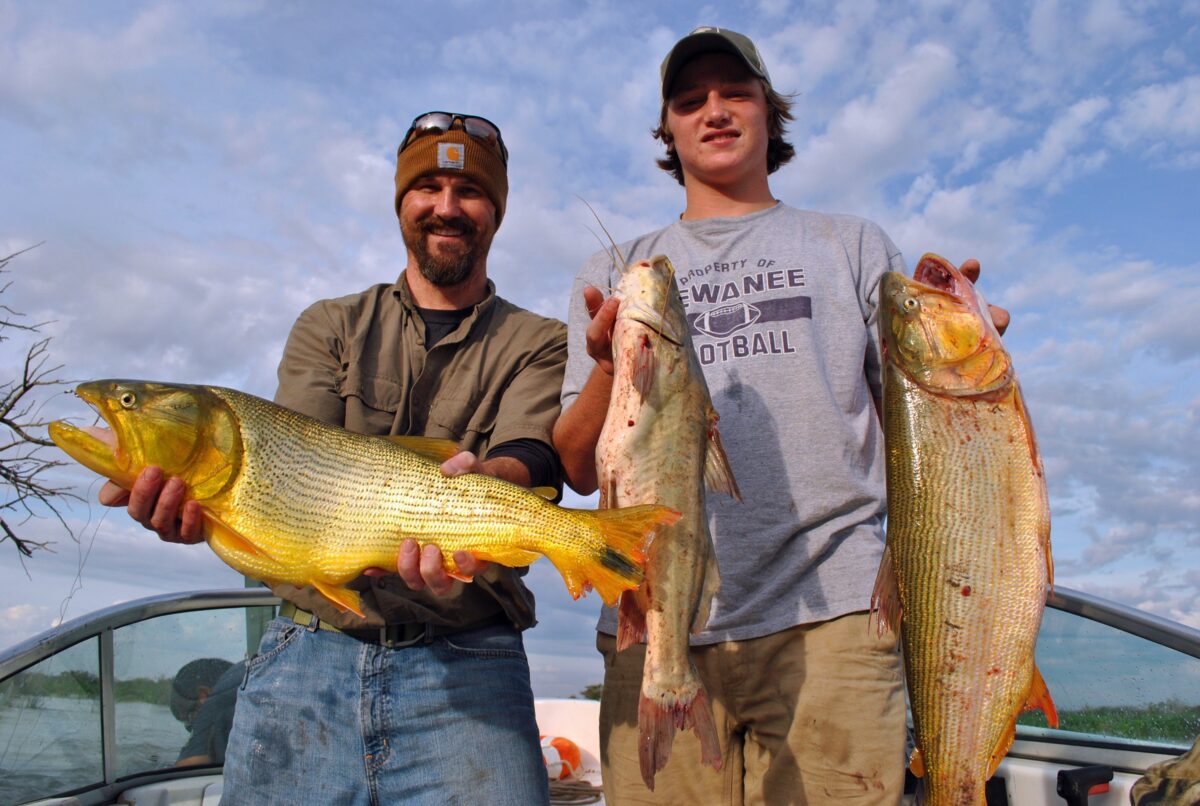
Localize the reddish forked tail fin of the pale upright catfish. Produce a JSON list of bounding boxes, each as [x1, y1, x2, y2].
[[637, 679, 721, 792]]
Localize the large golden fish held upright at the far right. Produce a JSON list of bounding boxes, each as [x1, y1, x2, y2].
[[872, 254, 1058, 806]]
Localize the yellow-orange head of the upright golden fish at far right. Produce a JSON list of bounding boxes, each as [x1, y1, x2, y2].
[[880, 254, 1014, 397]]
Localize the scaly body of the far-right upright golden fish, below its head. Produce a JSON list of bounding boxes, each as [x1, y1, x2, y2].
[[884, 363, 1049, 806]]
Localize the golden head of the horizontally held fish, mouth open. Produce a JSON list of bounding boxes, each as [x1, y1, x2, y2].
[[49, 380, 242, 500]]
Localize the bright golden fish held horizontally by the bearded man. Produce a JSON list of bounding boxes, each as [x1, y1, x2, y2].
[[49, 380, 679, 616]]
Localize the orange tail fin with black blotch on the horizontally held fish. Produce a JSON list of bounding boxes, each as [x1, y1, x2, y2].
[[551, 504, 682, 606]]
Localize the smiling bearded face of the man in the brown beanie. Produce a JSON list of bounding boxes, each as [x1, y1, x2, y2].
[[400, 174, 496, 285]]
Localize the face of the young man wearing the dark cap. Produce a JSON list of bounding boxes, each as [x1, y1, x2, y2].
[[667, 53, 769, 186]]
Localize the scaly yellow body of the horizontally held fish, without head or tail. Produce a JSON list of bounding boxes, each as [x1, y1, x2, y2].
[[209, 390, 604, 581]]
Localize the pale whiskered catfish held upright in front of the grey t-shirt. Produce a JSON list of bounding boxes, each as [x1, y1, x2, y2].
[[596, 255, 740, 789]]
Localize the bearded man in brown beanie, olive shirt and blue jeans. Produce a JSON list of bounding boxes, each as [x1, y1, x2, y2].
[[101, 112, 566, 806]]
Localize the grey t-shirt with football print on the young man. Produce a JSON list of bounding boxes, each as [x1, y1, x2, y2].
[[563, 204, 905, 644]]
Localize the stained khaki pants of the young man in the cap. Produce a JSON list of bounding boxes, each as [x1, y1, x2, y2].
[[596, 613, 906, 806]]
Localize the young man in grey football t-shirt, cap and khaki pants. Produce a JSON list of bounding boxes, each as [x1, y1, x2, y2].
[[554, 28, 1002, 804]]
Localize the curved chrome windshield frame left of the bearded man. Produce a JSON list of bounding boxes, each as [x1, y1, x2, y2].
[[0, 588, 281, 680]]
